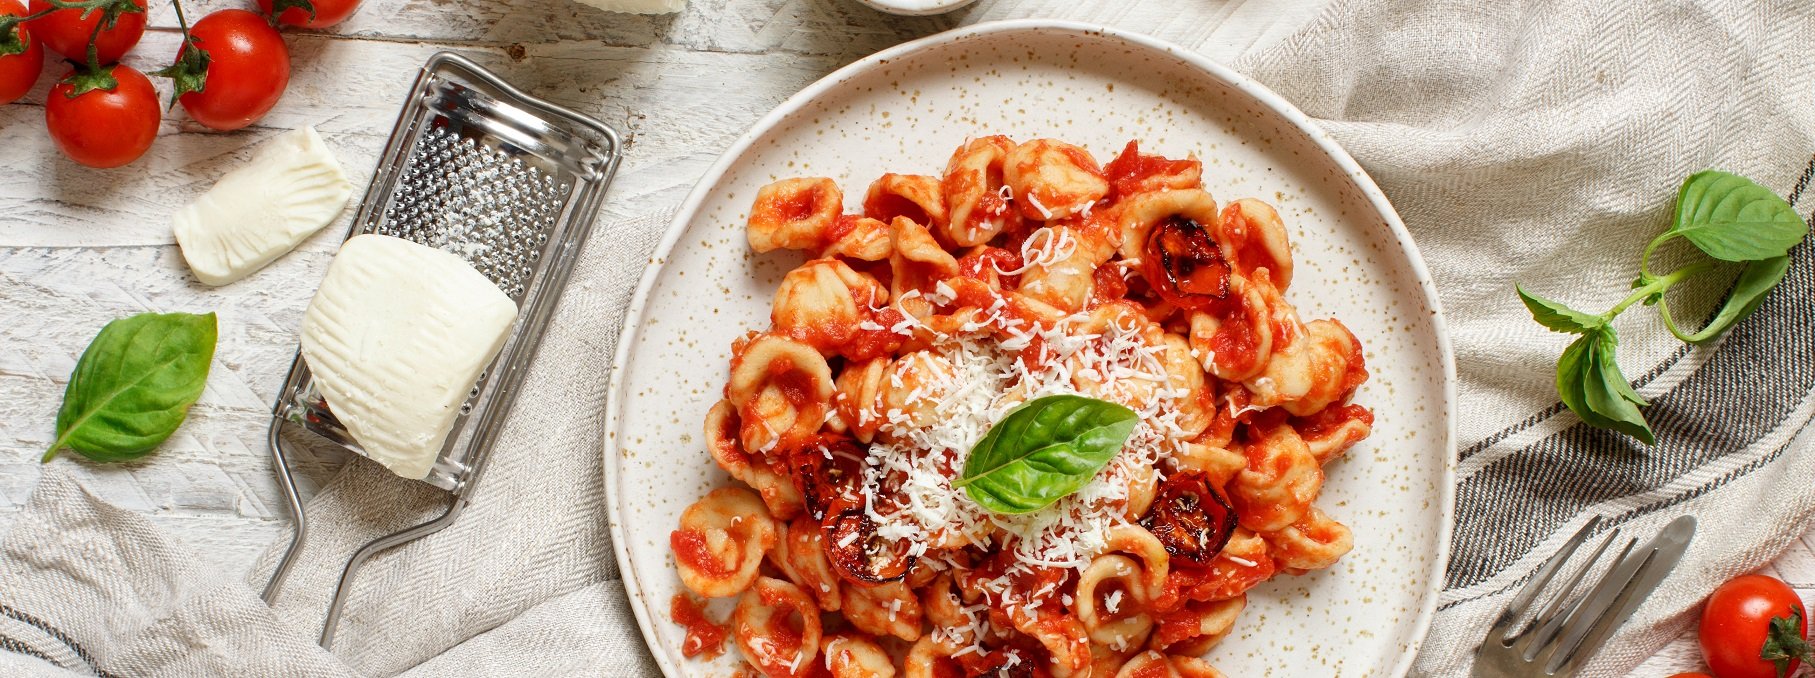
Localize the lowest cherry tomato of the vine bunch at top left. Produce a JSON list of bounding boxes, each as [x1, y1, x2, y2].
[[44, 65, 158, 167]]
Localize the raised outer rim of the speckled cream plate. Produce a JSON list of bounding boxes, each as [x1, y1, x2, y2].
[[603, 18, 1456, 676]]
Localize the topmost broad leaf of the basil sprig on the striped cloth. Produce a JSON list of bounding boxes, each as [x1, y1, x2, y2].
[[1666, 170, 1810, 261]]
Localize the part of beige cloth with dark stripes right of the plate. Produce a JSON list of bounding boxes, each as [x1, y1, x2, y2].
[[1238, 0, 1815, 676]]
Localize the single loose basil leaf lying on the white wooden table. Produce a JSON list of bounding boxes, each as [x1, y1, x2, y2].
[[44, 314, 216, 462]]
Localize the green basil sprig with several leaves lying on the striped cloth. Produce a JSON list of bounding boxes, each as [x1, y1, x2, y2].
[[1517, 170, 1810, 444]]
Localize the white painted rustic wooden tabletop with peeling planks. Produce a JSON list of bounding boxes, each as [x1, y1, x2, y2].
[[0, 0, 1815, 674]]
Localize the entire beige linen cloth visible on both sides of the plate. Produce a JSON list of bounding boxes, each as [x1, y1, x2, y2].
[[0, 0, 1815, 676]]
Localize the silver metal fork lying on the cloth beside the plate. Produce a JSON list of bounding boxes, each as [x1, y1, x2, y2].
[[1472, 515, 1695, 678]]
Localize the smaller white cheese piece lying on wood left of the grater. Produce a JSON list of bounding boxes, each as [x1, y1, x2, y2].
[[171, 127, 352, 285]]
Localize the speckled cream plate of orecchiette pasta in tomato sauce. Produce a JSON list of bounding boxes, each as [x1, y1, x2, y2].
[[604, 22, 1454, 678]]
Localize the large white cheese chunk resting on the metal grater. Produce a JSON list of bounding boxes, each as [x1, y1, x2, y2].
[[303, 234, 517, 479]]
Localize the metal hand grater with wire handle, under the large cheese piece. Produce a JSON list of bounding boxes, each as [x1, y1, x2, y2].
[[263, 53, 619, 647]]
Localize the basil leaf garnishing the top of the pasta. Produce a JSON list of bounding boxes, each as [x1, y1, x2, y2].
[[951, 395, 1140, 515]]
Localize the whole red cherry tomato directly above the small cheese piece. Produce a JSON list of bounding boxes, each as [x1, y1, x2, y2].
[[178, 9, 290, 131]]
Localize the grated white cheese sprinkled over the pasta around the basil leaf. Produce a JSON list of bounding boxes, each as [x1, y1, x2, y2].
[[864, 300, 1185, 605]]
